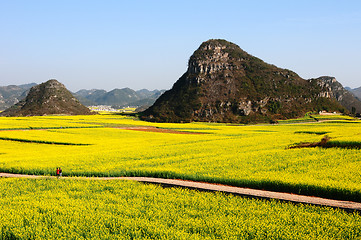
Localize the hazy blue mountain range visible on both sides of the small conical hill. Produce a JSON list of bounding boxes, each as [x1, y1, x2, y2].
[[0, 83, 165, 110]]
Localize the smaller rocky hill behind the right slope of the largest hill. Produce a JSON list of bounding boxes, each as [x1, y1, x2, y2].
[[315, 76, 361, 113]]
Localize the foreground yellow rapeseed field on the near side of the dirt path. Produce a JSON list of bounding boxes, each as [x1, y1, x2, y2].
[[0, 179, 361, 240]]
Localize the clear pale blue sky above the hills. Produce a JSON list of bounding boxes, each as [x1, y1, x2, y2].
[[0, 0, 361, 91]]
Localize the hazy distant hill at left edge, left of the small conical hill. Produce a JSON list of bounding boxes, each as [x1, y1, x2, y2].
[[0, 83, 37, 110]]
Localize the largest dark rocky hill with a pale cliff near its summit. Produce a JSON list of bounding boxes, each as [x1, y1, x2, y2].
[[143, 40, 344, 122]]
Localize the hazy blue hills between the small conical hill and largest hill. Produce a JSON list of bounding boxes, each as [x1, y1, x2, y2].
[[74, 88, 165, 108]]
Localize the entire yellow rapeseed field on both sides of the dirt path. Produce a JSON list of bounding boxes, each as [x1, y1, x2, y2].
[[0, 115, 361, 239]]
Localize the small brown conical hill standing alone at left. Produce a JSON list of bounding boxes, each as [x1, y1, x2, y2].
[[0, 79, 92, 116]]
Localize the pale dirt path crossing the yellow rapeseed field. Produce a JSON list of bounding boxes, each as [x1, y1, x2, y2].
[[0, 173, 361, 211]]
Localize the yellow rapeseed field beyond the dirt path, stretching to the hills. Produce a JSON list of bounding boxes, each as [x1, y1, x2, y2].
[[0, 115, 361, 201]]
